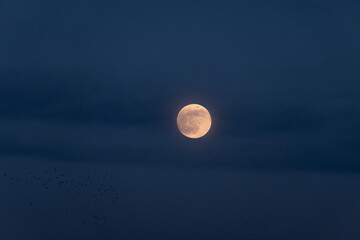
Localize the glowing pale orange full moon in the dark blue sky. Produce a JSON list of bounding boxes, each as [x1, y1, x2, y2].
[[177, 104, 211, 138]]
